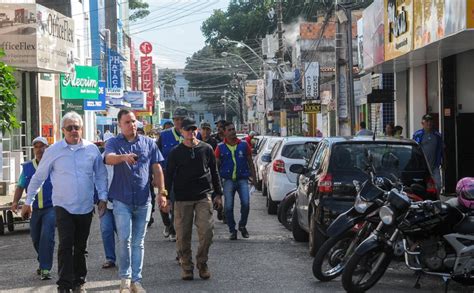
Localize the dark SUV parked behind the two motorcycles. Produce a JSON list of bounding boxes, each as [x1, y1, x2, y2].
[[291, 137, 438, 256]]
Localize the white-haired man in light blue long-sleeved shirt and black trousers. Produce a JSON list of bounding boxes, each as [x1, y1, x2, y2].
[[21, 112, 107, 292]]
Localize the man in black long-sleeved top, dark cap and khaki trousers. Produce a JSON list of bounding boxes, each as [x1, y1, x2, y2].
[[165, 118, 222, 280]]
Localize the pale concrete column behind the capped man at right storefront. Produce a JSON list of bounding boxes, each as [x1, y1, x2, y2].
[[407, 65, 426, 137]]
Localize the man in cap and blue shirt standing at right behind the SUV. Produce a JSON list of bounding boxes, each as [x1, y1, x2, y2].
[[413, 114, 443, 191]]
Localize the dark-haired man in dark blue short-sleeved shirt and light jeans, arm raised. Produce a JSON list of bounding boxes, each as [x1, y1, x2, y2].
[[105, 109, 168, 292]]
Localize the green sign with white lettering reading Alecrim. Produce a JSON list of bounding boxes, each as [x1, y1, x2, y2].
[[60, 65, 99, 100]]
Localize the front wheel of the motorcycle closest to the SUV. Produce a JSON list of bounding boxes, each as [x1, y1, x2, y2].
[[313, 231, 358, 282]]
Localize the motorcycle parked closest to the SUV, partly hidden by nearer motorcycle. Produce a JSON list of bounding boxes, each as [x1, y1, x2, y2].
[[312, 166, 425, 282]]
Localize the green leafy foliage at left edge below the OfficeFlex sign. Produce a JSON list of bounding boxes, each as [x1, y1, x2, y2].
[[0, 50, 20, 133]]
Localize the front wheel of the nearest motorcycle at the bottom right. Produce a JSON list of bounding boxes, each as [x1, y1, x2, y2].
[[342, 245, 393, 293]]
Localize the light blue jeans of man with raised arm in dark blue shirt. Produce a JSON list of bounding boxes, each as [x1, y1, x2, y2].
[[114, 200, 151, 282]]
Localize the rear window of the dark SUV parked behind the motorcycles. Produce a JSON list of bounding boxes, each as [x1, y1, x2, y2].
[[331, 143, 427, 176]]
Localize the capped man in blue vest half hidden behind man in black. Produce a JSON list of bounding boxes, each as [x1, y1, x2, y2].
[[157, 107, 188, 241]]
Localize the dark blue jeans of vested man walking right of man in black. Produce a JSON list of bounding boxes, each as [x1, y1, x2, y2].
[[224, 179, 250, 233]]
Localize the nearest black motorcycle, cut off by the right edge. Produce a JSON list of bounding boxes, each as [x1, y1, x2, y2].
[[342, 189, 474, 292]]
